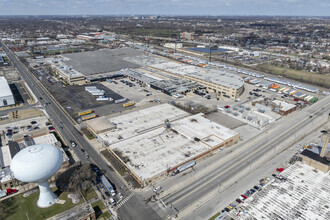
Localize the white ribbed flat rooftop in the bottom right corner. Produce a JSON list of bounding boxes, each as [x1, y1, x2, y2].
[[235, 162, 330, 219]]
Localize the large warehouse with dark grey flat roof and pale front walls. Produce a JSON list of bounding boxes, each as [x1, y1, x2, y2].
[[48, 48, 141, 85]]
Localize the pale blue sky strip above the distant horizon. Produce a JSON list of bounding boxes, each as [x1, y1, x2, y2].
[[0, 0, 330, 16]]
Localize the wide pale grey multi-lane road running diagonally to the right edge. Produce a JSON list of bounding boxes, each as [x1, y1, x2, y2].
[[162, 94, 330, 215]]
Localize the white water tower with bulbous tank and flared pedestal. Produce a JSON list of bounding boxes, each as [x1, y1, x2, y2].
[[10, 144, 63, 208]]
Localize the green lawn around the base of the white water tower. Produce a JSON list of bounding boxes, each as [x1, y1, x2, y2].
[[0, 187, 97, 220]]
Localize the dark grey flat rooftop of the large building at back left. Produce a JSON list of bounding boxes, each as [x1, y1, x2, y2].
[[62, 48, 141, 75]]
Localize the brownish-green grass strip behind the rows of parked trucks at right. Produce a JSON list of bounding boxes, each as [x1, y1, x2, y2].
[[252, 64, 330, 88]]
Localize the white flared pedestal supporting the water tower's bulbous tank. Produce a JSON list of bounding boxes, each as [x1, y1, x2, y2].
[[37, 180, 57, 208]]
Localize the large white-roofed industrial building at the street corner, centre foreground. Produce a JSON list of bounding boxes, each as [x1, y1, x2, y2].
[[87, 104, 239, 186]]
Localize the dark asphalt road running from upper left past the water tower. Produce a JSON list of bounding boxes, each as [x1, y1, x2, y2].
[[0, 41, 160, 220]]
